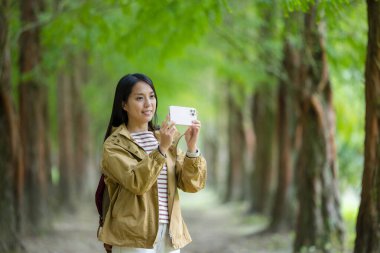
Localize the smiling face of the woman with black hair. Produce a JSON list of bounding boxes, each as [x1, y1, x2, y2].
[[123, 81, 156, 125]]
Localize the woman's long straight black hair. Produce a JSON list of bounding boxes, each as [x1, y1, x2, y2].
[[104, 73, 158, 141]]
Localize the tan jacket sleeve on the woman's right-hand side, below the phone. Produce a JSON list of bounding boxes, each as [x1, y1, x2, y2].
[[176, 150, 207, 192]]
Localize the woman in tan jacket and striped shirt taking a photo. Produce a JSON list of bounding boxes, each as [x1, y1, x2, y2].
[[99, 74, 206, 253]]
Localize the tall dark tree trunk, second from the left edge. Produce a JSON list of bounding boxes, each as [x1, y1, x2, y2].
[[19, 0, 50, 233]]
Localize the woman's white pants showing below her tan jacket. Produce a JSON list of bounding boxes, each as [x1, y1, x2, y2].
[[112, 223, 180, 253]]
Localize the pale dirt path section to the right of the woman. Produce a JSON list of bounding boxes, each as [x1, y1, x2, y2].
[[181, 192, 292, 253]]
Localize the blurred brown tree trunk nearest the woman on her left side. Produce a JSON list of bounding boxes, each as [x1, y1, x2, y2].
[[57, 52, 90, 210]]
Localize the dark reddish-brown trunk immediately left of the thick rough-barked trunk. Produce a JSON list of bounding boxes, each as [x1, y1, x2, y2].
[[268, 13, 300, 232]]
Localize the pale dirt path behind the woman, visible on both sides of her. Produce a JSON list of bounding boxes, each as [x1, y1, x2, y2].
[[23, 191, 292, 253]]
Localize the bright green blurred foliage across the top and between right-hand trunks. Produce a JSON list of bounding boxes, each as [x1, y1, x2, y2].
[[10, 0, 367, 185]]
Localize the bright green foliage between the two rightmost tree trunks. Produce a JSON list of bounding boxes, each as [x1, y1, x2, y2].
[[326, 0, 367, 192]]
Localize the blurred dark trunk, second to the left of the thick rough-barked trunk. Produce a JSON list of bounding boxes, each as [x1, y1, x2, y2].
[[249, 91, 274, 213]]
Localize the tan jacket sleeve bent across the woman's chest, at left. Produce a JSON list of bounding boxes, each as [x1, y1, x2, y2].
[[102, 142, 165, 195]]
